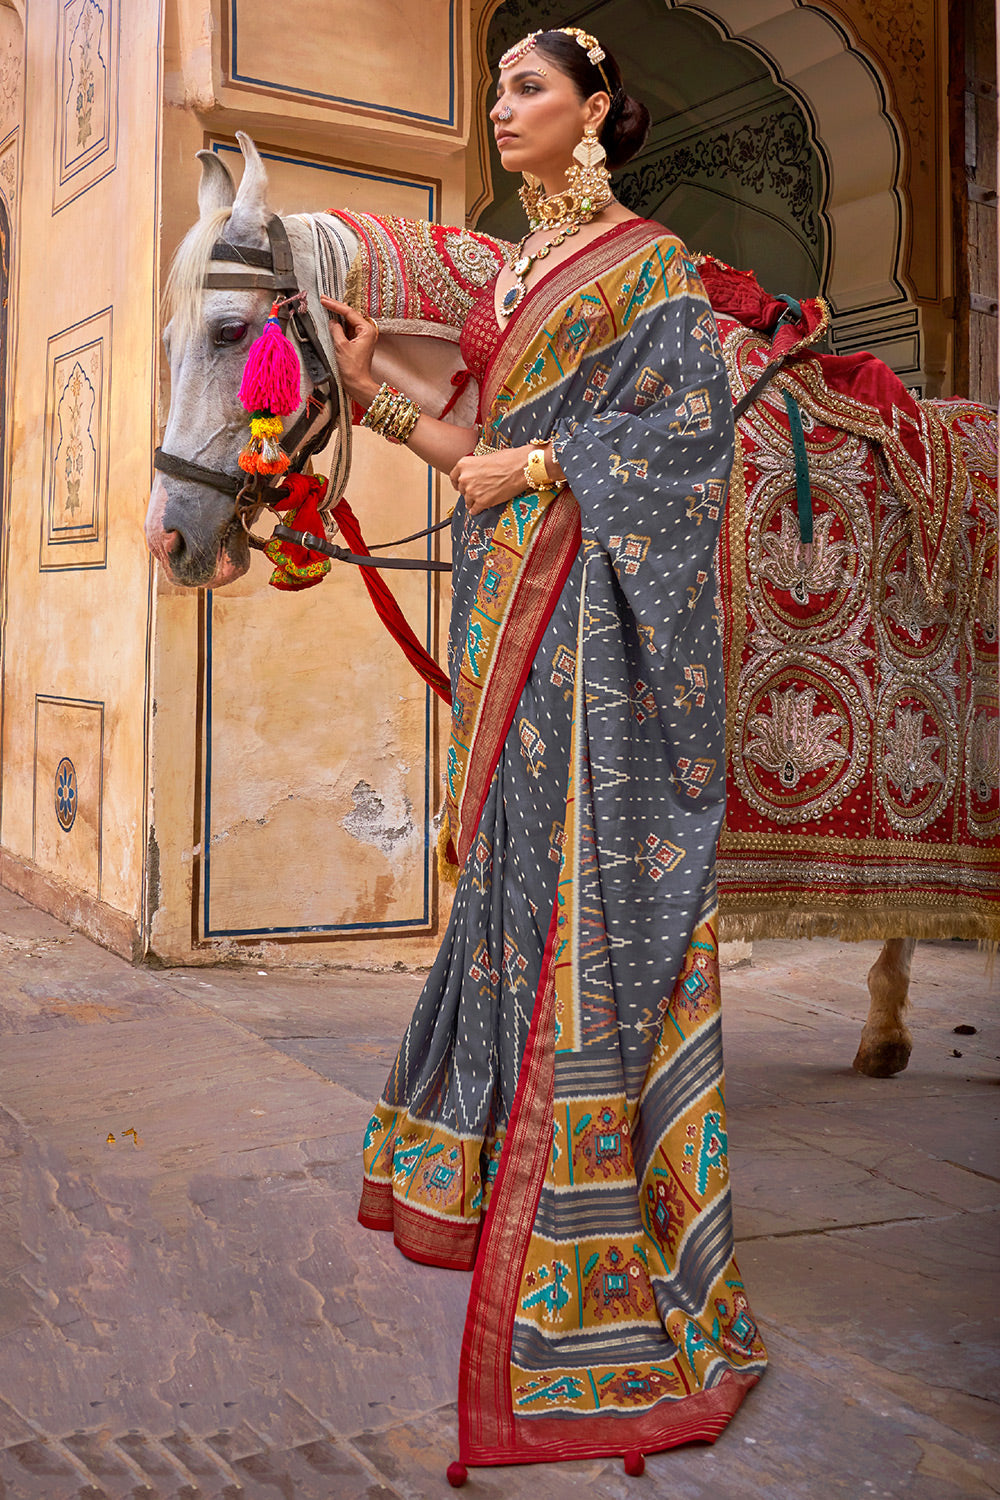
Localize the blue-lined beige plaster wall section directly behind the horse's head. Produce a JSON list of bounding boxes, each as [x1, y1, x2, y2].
[[150, 0, 466, 966]]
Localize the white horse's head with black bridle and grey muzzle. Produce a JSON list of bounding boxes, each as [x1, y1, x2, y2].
[[145, 132, 336, 588]]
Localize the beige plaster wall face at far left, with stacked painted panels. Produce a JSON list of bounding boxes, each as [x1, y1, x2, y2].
[[0, 0, 159, 945]]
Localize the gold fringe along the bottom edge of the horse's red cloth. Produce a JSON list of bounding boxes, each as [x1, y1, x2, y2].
[[718, 896, 1000, 954]]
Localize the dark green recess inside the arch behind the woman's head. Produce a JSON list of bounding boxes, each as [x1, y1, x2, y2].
[[478, 0, 829, 306]]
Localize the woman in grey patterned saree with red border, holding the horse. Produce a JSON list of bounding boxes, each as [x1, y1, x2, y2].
[[320, 27, 766, 1482]]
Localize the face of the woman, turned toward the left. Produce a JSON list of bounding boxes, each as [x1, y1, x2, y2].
[[490, 50, 610, 192]]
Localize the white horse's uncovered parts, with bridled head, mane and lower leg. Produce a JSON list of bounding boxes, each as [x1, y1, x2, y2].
[[145, 134, 941, 1077]]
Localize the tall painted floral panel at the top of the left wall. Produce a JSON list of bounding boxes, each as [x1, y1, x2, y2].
[[52, 0, 120, 213]]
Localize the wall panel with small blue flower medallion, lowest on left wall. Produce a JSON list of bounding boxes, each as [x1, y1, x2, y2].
[[31, 695, 103, 897]]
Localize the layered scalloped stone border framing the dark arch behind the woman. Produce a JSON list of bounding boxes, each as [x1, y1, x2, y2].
[[469, 0, 943, 393]]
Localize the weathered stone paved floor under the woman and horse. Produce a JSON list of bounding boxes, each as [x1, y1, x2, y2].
[[0, 891, 1000, 1500]]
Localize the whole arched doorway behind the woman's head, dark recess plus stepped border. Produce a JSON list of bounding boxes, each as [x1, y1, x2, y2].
[[469, 0, 946, 395]]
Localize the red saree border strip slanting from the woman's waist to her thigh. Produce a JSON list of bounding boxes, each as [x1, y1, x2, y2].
[[456, 492, 580, 869]]
